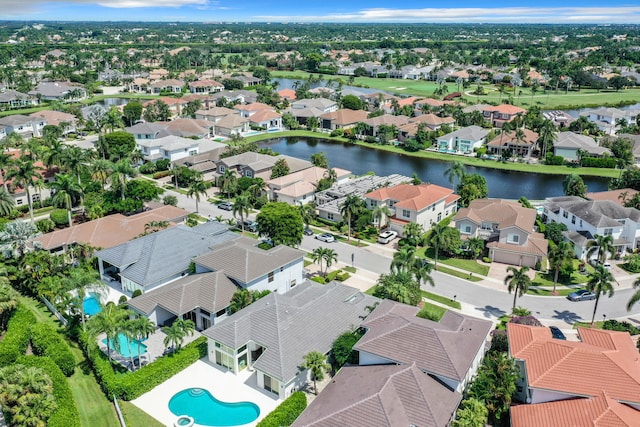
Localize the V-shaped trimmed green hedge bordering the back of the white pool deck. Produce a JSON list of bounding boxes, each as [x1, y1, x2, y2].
[[80, 334, 207, 400]]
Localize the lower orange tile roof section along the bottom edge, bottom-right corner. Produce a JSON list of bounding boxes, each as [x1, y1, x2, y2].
[[511, 392, 640, 427]]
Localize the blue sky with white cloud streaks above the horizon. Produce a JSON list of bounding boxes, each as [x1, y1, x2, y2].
[[0, 0, 640, 24]]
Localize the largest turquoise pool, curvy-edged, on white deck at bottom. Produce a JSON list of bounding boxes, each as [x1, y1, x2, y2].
[[169, 388, 260, 427]]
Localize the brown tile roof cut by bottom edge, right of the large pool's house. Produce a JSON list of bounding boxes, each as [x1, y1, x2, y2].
[[292, 363, 462, 427]]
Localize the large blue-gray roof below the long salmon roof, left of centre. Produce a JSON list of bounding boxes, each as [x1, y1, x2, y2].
[[96, 222, 238, 286]]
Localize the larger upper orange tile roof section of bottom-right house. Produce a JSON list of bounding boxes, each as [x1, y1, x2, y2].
[[507, 323, 640, 404]]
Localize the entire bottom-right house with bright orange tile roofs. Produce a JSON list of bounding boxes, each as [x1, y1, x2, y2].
[[507, 323, 640, 427]]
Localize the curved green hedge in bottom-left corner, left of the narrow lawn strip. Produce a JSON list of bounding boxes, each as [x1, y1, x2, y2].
[[18, 356, 80, 427]]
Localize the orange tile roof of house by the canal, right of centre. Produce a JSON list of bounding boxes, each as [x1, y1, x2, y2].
[[365, 184, 459, 212]]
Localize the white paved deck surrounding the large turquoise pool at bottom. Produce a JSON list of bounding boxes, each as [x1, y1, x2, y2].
[[131, 358, 280, 427]]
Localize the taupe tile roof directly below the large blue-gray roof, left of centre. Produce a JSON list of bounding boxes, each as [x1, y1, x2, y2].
[[128, 271, 238, 316]]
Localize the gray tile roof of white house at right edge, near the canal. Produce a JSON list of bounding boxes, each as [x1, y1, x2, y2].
[[545, 196, 640, 228]]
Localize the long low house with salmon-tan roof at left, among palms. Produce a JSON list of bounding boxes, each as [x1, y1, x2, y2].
[[35, 205, 189, 252]]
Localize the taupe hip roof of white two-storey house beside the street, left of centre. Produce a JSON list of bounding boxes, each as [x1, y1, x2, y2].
[[193, 238, 305, 283]]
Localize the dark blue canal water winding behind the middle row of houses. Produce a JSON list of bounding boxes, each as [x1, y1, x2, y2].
[[260, 137, 608, 200]]
